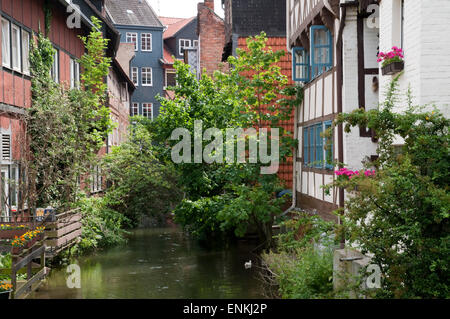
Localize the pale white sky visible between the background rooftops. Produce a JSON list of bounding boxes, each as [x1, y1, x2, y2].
[[147, 0, 224, 18]]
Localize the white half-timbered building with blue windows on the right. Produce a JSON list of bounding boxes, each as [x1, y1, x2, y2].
[[286, 0, 450, 219]]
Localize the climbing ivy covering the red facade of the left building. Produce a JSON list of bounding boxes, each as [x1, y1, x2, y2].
[[27, 17, 112, 209]]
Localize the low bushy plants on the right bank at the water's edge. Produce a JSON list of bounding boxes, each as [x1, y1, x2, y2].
[[262, 213, 334, 299]]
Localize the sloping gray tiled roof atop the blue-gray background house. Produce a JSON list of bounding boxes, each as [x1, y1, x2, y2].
[[105, 0, 163, 27]]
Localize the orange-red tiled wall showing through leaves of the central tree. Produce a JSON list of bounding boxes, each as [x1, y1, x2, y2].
[[238, 37, 294, 188]]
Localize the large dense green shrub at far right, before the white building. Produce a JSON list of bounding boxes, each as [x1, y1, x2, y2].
[[329, 78, 450, 298]]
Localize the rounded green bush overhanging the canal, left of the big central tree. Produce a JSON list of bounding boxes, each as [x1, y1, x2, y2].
[[101, 118, 182, 226]]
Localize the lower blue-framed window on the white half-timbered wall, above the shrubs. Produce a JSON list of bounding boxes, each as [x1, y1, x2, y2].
[[303, 121, 333, 170]]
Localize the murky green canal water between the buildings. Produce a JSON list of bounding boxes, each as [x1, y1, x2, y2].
[[31, 228, 264, 299]]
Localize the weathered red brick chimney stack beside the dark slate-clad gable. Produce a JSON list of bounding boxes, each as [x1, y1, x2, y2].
[[197, 1, 225, 75]]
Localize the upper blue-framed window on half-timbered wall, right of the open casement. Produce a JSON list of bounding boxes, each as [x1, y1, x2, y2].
[[310, 25, 333, 78]]
